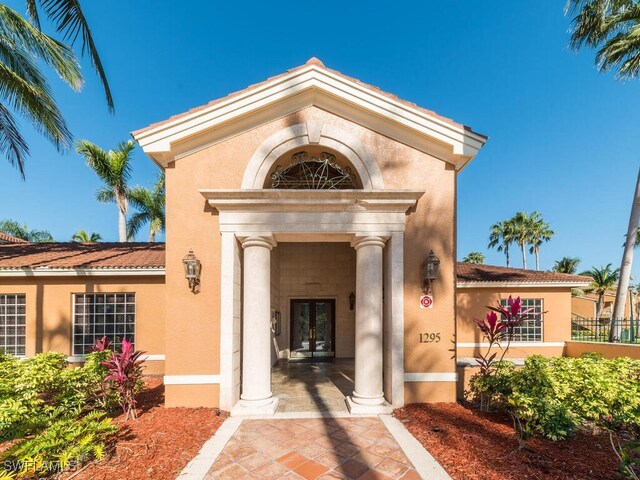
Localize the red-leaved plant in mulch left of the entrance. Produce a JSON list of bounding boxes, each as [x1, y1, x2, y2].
[[102, 338, 144, 420]]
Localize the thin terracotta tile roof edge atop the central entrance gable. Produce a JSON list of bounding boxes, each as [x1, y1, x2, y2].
[[131, 57, 489, 138]]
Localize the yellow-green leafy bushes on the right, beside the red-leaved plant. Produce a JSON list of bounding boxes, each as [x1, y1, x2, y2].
[[471, 354, 640, 440]]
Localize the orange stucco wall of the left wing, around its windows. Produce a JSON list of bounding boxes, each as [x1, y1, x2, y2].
[[0, 276, 165, 375]]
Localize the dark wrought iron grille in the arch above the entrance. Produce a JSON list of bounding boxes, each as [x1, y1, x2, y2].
[[271, 152, 358, 190]]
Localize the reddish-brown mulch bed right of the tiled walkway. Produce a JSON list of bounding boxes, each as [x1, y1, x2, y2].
[[394, 403, 623, 480]]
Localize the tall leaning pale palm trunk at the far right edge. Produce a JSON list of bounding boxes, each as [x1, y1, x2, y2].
[[609, 170, 640, 342]]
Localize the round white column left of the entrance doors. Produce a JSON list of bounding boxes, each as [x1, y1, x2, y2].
[[232, 236, 278, 415]]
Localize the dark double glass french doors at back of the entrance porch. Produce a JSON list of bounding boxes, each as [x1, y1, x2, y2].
[[289, 299, 336, 358]]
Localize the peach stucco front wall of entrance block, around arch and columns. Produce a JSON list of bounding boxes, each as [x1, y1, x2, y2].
[[166, 107, 456, 406]]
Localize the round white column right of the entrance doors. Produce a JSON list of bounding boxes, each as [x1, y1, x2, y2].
[[347, 236, 391, 413]]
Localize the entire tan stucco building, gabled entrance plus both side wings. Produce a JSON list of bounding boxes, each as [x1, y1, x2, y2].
[[0, 59, 592, 414]]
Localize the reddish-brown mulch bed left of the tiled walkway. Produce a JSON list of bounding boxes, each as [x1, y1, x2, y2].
[[66, 378, 227, 480]]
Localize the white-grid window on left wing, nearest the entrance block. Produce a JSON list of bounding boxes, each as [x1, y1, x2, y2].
[[73, 293, 136, 355]]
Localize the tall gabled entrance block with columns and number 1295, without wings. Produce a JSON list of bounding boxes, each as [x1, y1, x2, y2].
[[133, 59, 486, 413]]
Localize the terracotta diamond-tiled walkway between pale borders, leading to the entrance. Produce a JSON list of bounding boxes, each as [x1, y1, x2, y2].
[[205, 417, 420, 480]]
